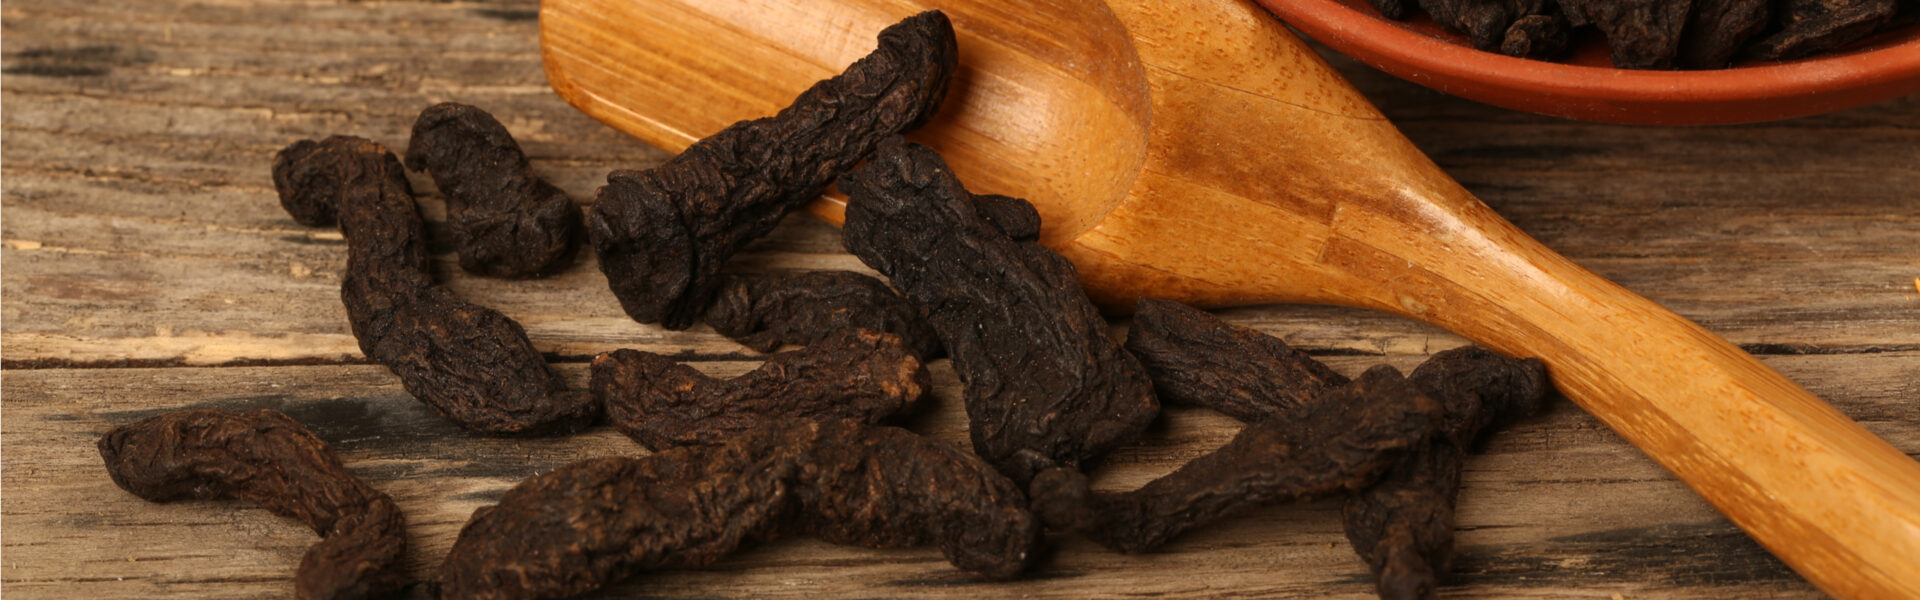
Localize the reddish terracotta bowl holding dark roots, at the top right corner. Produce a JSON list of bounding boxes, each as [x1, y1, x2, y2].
[[1258, 0, 1920, 125]]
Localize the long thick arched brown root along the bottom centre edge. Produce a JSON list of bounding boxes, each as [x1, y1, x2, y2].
[[440, 419, 1039, 600]]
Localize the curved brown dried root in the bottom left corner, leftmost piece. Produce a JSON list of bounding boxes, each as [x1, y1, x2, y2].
[[100, 410, 409, 600]]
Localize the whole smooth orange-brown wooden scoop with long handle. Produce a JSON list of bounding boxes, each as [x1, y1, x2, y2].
[[540, 0, 1920, 598]]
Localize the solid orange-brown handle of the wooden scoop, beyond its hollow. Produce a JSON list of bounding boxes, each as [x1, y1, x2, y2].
[[1060, 0, 1920, 598]]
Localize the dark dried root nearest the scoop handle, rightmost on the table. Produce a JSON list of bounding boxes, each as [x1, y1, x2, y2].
[[1342, 346, 1548, 600]]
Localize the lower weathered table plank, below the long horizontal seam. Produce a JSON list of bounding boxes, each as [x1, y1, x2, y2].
[[0, 352, 1920, 598]]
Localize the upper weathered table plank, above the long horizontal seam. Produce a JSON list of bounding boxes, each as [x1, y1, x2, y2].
[[0, 2, 1920, 363]]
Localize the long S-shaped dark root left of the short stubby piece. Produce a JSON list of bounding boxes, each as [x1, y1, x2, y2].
[[273, 137, 599, 433]]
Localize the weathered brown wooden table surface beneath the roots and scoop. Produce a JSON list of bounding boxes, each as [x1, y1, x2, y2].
[[0, 0, 1920, 598]]
